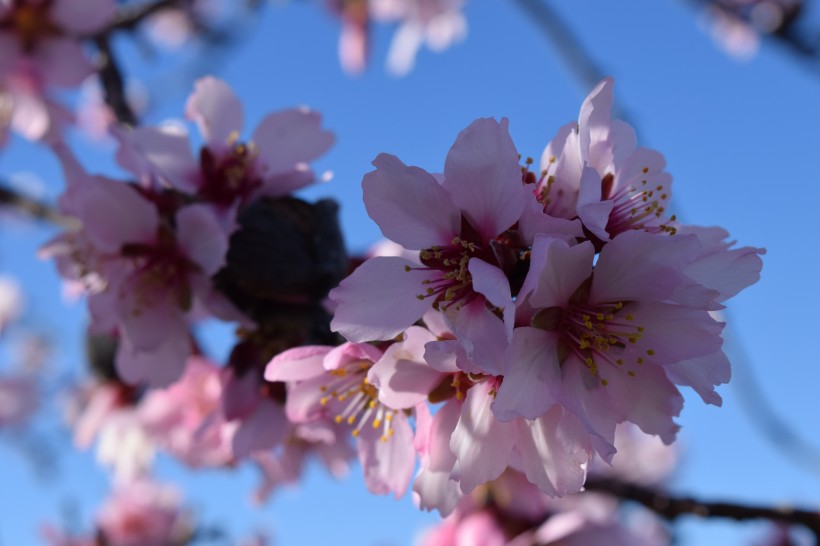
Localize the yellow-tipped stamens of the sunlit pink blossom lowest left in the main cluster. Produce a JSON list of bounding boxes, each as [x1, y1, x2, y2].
[[319, 361, 396, 442]]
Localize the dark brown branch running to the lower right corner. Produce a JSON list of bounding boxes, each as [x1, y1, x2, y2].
[[584, 478, 820, 543]]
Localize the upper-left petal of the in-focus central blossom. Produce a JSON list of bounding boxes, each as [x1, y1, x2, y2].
[[362, 154, 461, 250]]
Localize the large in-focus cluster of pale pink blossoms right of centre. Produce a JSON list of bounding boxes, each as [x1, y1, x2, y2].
[[326, 79, 764, 506]]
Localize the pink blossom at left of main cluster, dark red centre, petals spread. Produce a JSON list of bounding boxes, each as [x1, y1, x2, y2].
[[330, 119, 528, 372]]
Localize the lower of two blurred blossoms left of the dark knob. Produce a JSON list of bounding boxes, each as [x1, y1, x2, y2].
[[45, 148, 234, 386]]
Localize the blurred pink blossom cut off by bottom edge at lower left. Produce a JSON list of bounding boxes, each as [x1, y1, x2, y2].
[[97, 481, 193, 546]]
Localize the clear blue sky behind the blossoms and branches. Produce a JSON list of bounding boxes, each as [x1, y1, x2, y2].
[[0, 0, 820, 546]]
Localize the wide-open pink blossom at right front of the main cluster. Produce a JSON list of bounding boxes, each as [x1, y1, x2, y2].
[[493, 231, 728, 460]]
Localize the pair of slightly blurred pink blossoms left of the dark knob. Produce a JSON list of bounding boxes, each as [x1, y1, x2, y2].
[[45, 78, 333, 386]]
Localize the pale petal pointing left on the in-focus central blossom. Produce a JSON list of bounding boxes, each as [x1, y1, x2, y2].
[[329, 256, 435, 342]]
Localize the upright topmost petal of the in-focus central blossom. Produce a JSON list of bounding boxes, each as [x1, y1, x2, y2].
[[444, 118, 531, 240]]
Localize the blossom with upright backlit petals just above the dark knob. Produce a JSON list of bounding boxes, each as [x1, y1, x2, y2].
[[117, 76, 334, 210]]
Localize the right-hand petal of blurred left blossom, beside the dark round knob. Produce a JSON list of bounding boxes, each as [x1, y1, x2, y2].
[[176, 204, 228, 276]]
